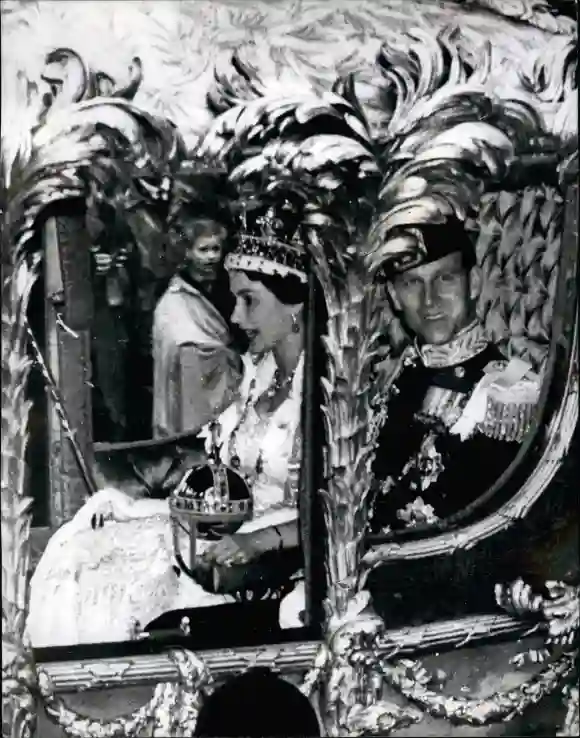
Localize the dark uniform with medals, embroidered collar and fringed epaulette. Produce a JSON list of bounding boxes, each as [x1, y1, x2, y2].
[[370, 323, 540, 533]]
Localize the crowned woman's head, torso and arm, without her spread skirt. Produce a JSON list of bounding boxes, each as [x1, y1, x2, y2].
[[195, 208, 306, 565]]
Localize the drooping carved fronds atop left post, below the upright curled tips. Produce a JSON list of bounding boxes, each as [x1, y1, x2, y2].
[[6, 98, 185, 290]]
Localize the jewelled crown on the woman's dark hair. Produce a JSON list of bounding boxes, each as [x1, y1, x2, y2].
[[225, 201, 307, 282]]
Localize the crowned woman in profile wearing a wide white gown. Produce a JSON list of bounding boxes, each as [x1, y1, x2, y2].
[[27, 201, 306, 647]]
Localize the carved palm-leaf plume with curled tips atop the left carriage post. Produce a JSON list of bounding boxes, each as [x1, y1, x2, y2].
[[2, 48, 195, 284]]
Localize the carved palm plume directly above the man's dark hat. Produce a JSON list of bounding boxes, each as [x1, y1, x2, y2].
[[366, 40, 545, 272]]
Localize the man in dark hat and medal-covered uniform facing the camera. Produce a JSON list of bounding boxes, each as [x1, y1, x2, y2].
[[371, 220, 540, 533]]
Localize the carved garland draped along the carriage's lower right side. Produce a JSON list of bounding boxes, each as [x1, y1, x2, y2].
[[304, 580, 580, 735]]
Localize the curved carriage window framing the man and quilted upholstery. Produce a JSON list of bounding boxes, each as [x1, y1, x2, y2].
[[373, 186, 566, 540]]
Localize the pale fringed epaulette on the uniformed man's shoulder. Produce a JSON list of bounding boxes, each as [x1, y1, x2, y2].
[[450, 359, 541, 442]]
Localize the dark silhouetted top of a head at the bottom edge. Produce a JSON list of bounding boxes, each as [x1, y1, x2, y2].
[[194, 668, 320, 738]]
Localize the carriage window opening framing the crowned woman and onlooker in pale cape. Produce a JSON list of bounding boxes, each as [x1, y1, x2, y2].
[[24, 181, 324, 647]]
